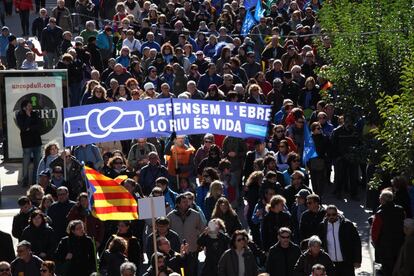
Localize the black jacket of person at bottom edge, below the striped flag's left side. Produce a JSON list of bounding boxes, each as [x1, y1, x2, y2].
[[56, 234, 96, 276]]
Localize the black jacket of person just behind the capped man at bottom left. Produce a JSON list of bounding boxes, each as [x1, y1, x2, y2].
[[22, 225, 56, 260]]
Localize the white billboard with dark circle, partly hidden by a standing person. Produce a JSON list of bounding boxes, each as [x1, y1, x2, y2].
[[2, 71, 66, 159]]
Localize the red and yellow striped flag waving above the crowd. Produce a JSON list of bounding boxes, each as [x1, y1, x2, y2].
[[85, 166, 138, 221]]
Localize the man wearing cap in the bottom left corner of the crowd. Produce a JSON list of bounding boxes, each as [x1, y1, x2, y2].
[[10, 240, 43, 276]]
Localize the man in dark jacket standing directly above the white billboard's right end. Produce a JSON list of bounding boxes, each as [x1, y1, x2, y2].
[[40, 17, 63, 69]]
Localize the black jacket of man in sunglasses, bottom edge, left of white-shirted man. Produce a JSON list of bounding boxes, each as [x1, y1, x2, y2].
[[266, 242, 301, 276]]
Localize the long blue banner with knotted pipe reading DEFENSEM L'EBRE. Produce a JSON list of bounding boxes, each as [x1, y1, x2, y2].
[[63, 99, 271, 146]]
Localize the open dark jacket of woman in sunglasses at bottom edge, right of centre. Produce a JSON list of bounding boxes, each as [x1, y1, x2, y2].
[[218, 248, 257, 276]]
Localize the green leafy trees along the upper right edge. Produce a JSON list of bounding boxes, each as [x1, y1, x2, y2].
[[319, 0, 414, 188]]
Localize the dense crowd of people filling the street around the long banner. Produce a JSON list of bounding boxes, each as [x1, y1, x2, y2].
[[0, 0, 414, 276]]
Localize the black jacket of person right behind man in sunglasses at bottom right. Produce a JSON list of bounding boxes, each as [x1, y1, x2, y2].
[[261, 211, 290, 251]]
